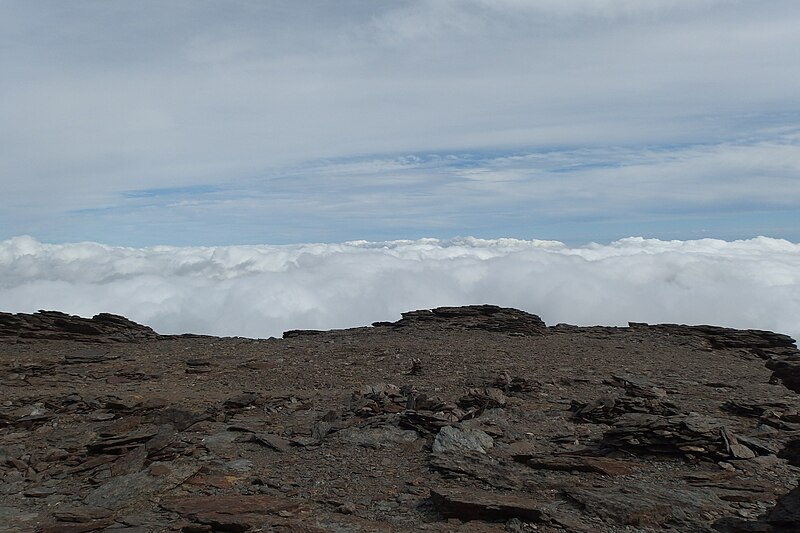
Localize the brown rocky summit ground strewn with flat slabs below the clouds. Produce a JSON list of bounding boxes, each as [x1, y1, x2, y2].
[[0, 305, 800, 533]]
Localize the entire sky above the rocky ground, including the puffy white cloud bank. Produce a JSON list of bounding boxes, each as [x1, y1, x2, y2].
[[0, 0, 800, 337]]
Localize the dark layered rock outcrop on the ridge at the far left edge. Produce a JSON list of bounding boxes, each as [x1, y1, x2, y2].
[[0, 311, 158, 342]]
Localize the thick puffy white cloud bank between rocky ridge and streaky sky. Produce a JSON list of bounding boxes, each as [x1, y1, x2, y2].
[[0, 237, 800, 338]]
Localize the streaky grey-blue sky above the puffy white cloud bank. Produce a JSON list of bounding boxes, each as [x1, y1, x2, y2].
[[0, 0, 800, 246]]
